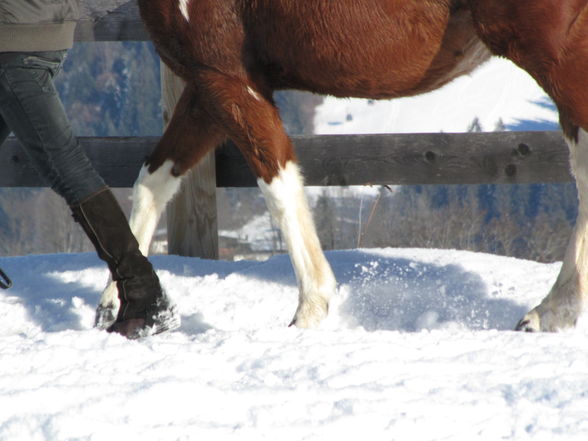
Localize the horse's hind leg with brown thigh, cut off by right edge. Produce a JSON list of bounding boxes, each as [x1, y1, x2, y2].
[[472, 0, 588, 331]]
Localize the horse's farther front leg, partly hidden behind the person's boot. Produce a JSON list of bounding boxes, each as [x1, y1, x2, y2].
[[95, 86, 224, 329]]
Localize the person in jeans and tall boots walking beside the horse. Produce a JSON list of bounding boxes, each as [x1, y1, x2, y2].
[[0, 0, 179, 338]]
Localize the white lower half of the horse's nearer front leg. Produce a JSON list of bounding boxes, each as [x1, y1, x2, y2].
[[257, 162, 336, 328]]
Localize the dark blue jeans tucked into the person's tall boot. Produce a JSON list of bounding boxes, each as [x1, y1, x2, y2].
[[0, 51, 106, 205]]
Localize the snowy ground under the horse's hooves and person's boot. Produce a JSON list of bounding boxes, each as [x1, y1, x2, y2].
[[0, 249, 588, 441]]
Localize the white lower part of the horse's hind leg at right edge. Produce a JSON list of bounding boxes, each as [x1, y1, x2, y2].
[[523, 130, 588, 331]]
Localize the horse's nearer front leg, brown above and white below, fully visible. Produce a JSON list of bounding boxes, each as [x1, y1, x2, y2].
[[199, 71, 336, 328]]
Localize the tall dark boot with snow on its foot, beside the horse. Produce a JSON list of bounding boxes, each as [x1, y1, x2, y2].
[[71, 189, 179, 338]]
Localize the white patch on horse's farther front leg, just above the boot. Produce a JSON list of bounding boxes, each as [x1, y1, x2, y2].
[[129, 160, 181, 256]]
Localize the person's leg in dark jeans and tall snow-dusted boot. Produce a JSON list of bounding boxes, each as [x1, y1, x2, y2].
[[0, 52, 179, 338]]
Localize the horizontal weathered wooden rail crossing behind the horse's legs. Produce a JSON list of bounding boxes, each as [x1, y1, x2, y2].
[[0, 132, 572, 187]]
